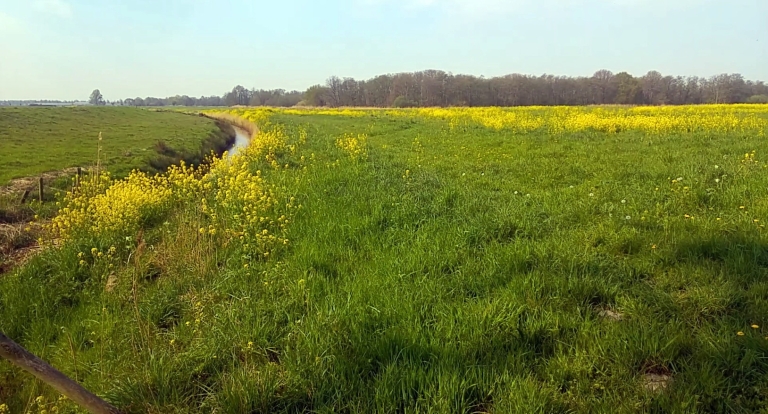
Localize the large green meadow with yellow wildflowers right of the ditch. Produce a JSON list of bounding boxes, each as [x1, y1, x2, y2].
[[0, 106, 768, 413]]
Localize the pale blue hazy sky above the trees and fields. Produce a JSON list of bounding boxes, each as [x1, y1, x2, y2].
[[0, 0, 768, 100]]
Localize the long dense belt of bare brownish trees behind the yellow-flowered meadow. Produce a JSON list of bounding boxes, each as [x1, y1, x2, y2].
[[304, 70, 768, 107]]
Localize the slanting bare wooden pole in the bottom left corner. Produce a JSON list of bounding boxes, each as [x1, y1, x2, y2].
[[0, 332, 120, 414]]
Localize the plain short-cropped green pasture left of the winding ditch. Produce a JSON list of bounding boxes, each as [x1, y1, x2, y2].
[[0, 107, 231, 185]]
